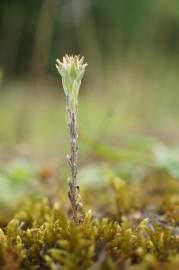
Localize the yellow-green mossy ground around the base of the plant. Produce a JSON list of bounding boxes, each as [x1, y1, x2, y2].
[[0, 170, 179, 270]]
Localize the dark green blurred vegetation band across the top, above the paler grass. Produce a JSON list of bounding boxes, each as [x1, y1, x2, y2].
[[0, 0, 179, 76]]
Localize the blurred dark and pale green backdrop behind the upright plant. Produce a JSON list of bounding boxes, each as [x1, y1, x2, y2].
[[0, 0, 179, 162]]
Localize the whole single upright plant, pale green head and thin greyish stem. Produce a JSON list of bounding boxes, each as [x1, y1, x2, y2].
[[56, 55, 87, 223]]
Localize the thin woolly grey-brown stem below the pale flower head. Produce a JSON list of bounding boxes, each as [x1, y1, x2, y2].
[[66, 95, 82, 223]]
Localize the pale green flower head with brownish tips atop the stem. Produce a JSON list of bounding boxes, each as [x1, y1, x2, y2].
[[56, 55, 87, 108]]
